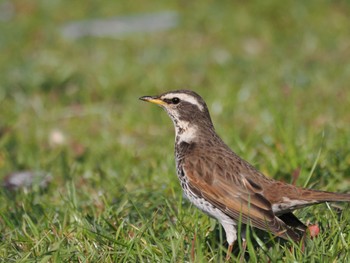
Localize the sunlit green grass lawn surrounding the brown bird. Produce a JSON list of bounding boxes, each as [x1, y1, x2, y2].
[[0, 0, 350, 262]]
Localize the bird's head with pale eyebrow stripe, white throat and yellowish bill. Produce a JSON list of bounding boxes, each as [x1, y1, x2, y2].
[[140, 90, 214, 142]]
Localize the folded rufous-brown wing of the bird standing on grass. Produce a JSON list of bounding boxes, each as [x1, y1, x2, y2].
[[183, 155, 299, 240]]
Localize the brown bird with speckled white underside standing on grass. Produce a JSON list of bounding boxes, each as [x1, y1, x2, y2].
[[139, 90, 350, 260]]
